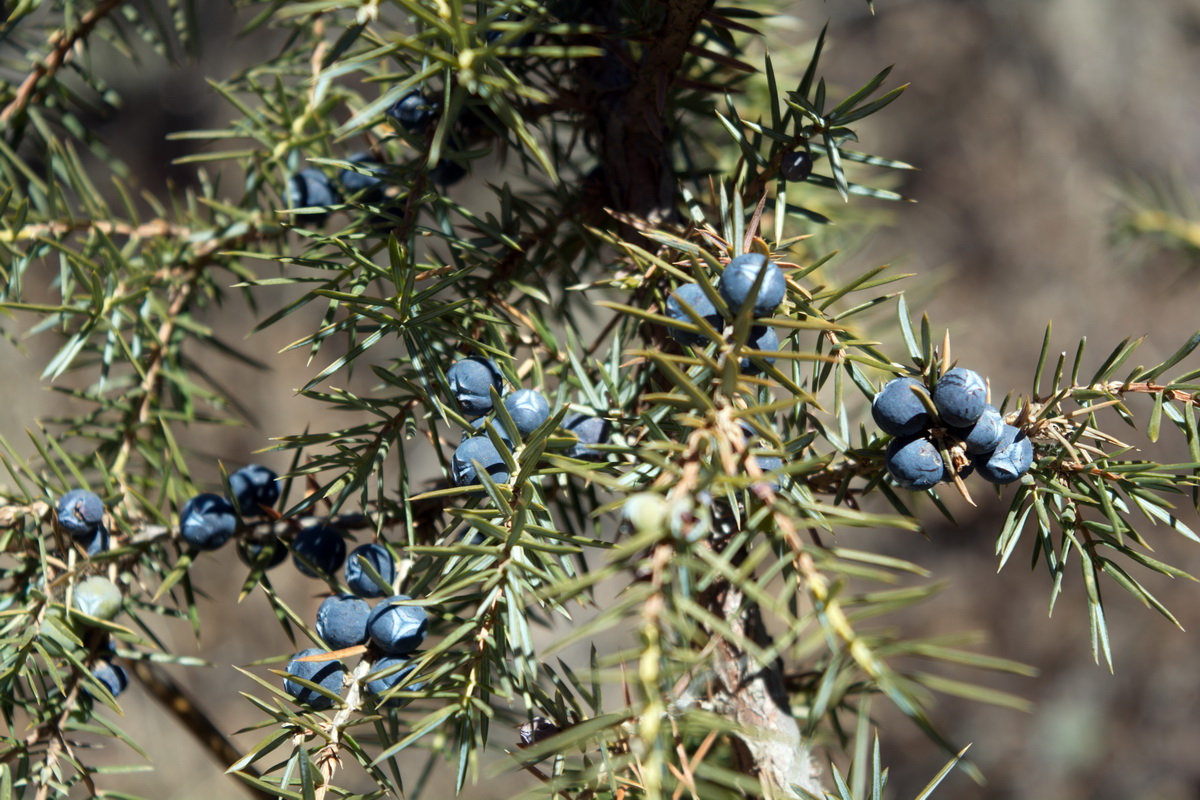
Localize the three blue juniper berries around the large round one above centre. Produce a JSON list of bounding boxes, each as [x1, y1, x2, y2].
[[666, 253, 787, 374]]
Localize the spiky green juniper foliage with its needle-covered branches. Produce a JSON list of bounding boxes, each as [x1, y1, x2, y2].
[[0, 0, 1200, 800]]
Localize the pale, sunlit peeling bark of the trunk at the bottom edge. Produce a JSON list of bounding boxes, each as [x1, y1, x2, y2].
[[709, 584, 821, 798]]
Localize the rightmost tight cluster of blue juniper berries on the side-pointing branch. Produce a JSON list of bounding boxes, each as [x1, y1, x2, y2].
[[871, 367, 1033, 491]]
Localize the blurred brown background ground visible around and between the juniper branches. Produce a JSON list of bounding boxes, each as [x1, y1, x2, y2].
[[7, 0, 1200, 800]]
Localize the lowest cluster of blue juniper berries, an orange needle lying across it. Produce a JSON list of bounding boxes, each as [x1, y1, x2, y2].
[[283, 585, 428, 710]]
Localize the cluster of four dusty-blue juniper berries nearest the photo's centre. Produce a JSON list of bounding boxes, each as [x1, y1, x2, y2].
[[446, 356, 611, 486]]
